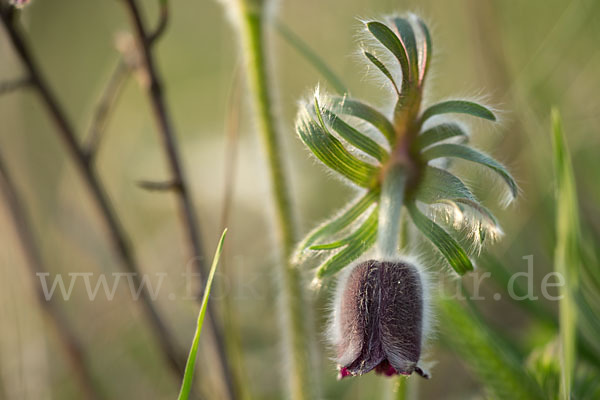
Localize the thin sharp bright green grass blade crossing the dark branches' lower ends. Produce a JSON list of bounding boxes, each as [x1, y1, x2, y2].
[[178, 229, 227, 400]]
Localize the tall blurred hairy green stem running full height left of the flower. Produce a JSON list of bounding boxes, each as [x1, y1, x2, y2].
[[239, 0, 312, 400]]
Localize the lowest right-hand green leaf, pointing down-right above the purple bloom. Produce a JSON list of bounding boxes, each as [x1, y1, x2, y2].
[[406, 200, 473, 275]]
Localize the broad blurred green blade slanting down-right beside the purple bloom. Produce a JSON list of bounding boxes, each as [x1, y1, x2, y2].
[[438, 298, 543, 400]]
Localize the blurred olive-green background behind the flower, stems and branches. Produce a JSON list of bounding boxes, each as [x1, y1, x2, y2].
[[0, 0, 600, 399]]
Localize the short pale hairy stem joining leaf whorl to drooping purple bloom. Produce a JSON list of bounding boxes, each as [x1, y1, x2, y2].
[[377, 164, 406, 258]]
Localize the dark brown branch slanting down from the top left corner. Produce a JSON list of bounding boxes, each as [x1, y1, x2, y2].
[[0, 4, 185, 379]]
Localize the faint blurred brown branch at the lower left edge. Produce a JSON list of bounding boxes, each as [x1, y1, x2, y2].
[[0, 152, 102, 399]]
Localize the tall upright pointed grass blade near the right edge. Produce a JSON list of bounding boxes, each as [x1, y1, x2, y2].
[[552, 110, 581, 400]]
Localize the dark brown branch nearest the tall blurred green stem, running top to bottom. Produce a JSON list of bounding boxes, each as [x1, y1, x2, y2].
[[120, 0, 235, 399]]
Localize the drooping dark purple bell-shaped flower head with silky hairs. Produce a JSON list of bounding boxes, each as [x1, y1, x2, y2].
[[332, 260, 428, 379]]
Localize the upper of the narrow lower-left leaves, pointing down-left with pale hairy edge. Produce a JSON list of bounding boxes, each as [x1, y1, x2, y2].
[[296, 190, 379, 258]]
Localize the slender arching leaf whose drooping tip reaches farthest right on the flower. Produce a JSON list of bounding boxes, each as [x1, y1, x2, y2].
[[421, 143, 519, 198]]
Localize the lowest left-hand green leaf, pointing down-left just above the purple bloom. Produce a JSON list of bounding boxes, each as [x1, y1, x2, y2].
[[317, 207, 379, 279]]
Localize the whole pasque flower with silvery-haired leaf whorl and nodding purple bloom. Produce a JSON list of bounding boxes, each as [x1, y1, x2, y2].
[[296, 15, 518, 377]]
